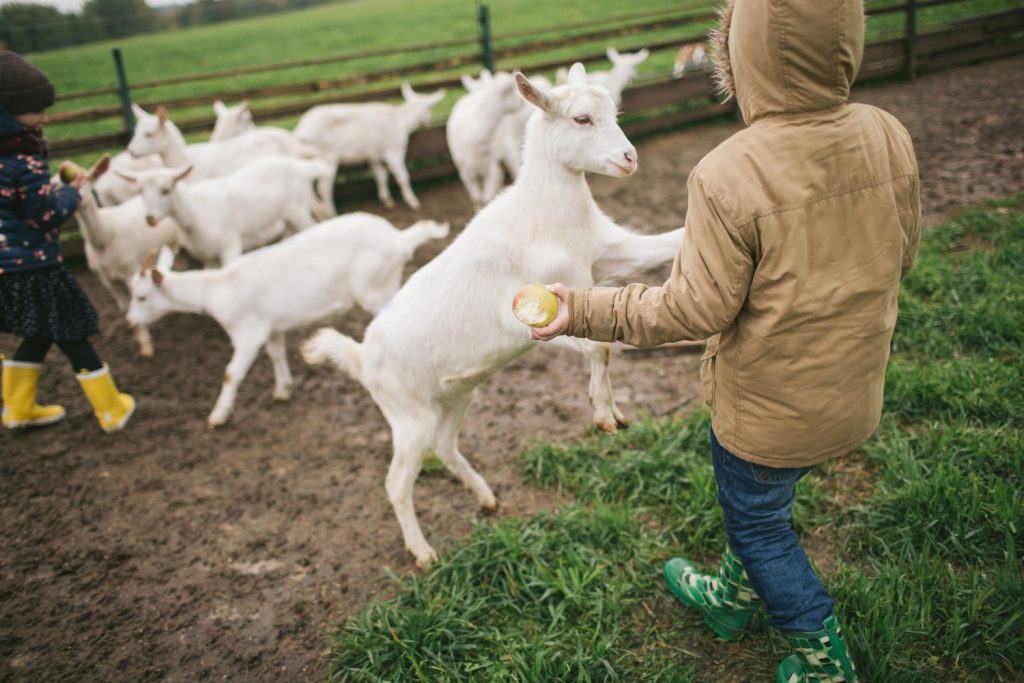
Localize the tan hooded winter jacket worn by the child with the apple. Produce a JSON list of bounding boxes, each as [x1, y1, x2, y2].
[[568, 0, 921, 467]]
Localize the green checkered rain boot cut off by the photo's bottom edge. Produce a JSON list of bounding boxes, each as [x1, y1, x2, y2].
[[775, 616, 858, 683]]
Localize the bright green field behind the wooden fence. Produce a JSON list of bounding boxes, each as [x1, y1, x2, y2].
[[30, 0, 1018, 166]]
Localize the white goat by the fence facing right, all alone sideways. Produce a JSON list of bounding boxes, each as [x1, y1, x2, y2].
[[293, 83, 445, 209]]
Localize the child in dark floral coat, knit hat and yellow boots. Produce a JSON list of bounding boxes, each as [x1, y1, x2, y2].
[[0, 50, 135, 432]]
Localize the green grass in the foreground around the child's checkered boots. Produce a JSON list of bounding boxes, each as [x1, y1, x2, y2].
[[332, 195, 1024, 683]]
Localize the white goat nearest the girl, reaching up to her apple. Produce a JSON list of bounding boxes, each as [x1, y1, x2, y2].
[[75, 156, 178, 357]]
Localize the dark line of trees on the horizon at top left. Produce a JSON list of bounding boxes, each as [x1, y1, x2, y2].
[[0, 0, 334, 53]]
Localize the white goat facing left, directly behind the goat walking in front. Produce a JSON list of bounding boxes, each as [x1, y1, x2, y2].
[[122, 157, 331, 266]]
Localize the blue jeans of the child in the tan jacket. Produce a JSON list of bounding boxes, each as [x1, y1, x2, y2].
[[711, 430, 835, 631]]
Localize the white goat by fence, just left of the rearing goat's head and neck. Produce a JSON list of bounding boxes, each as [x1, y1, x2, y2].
[[444, 69, 521, 211]]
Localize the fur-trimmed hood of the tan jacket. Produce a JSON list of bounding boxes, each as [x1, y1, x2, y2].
[[712, 0, 864, 124]]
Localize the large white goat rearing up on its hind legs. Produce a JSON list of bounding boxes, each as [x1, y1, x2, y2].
[[302, 63, 683, 567]]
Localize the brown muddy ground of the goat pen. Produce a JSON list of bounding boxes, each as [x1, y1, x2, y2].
[[0, 56, 1024, 682]]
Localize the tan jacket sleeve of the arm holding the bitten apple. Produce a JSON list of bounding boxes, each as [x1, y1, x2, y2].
[[566, 171, 755, 346]]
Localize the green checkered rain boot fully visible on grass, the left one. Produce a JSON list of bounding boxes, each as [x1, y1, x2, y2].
[[663, 549, 761, 640]]
